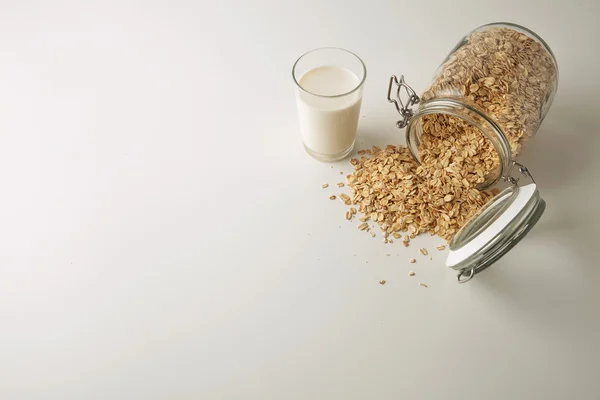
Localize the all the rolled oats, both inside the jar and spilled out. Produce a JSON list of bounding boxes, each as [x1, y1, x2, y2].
[[341, 28, 557, 241]]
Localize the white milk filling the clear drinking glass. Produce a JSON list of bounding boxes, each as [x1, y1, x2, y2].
[[296, 66, 362, 158]]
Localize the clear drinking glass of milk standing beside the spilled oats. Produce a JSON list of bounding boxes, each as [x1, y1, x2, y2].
[[292, 47, 367, 161]]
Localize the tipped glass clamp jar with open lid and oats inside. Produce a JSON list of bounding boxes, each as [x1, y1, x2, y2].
[[388, 23, 558, 282]]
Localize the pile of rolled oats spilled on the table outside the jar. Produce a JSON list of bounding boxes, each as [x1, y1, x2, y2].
[[348, 145, 491, 240]]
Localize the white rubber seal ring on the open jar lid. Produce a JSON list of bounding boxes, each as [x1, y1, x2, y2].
[[446, 183, 536, 269]]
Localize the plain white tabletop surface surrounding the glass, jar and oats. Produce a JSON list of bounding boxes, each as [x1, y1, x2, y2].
[[0, 0, 600, 400]]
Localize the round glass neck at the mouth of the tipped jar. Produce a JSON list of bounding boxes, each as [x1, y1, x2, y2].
[[406, 97, 512, 189]]
